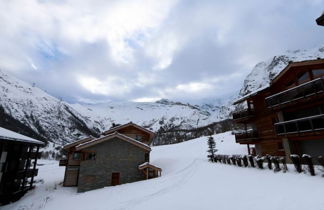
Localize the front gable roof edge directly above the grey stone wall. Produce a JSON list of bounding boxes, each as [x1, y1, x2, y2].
[[76, 132, 151, 151]]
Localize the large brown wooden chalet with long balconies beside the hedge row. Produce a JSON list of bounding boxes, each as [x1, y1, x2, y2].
[[233, 59, 324, 160]]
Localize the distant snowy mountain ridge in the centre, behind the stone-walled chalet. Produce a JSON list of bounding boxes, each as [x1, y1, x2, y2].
[[71, 99, 231, 131]]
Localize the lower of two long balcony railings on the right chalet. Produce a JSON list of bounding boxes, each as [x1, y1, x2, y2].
[[275, 114, 324, 135]]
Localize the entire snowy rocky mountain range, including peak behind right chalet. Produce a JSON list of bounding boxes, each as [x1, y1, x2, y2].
[[0, 47, 324, 145]]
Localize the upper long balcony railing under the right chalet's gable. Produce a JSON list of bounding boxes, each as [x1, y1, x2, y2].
[[265, 78, 324, 108]]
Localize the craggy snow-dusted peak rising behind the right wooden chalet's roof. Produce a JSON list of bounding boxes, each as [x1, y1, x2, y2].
[[240, 46, 324, 96]]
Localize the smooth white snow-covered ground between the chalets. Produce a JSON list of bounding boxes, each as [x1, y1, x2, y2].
[[2, 132, 324, 210]]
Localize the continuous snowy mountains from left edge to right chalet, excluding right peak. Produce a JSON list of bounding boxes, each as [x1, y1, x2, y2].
[[0, 71, 231, 144]]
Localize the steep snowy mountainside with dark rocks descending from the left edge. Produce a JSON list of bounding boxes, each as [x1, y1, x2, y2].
[[0, 70, 99, 143]]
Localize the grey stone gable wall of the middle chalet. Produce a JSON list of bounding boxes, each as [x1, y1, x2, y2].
[[78, 138, 147, 192]]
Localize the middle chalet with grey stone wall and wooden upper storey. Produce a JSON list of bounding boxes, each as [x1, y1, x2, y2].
[[60, 122, 162, 192]]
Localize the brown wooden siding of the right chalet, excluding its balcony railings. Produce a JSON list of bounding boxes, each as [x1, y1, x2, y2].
[[234, 59, 324, 158]]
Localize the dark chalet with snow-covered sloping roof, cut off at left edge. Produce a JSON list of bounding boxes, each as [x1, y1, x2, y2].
[[0, 127, 44, 205]]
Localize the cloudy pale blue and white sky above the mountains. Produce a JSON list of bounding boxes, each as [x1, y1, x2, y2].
[[0, 0, 324, 103]]
